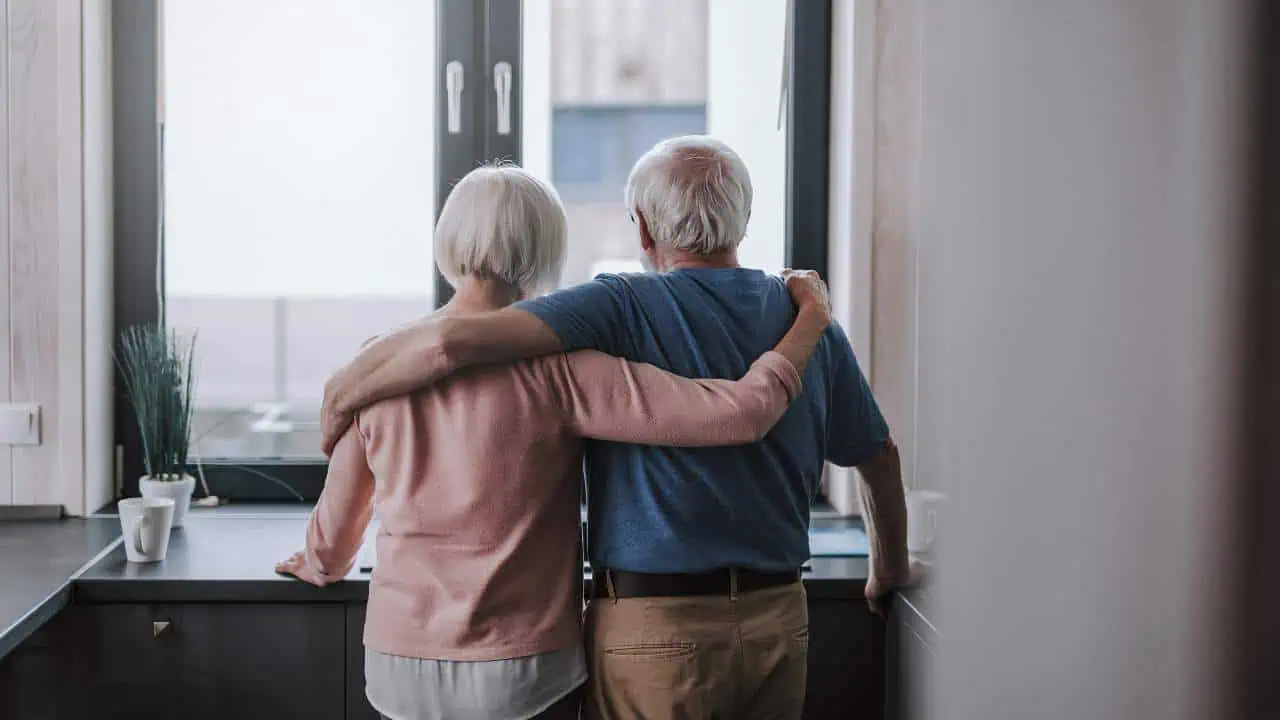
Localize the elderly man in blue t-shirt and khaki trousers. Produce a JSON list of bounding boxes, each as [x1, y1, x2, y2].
[[325, 136, 909, 720]]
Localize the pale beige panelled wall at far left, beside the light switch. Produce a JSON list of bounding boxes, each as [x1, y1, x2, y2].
[[0, 0, 109, 514]]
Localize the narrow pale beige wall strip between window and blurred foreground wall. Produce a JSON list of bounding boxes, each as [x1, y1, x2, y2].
[[828, 0, 943, 491]]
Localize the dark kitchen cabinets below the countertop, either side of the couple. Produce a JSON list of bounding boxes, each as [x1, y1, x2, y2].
[[0, 598, 901, 720]]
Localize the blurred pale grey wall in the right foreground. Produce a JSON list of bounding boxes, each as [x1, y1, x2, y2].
[[918, 0, 1243, 720]]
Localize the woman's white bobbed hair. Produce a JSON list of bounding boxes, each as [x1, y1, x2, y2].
[[435, 165, 568, 295]]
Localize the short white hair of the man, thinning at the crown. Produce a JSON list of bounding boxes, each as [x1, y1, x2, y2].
[[626, 135, 751, 255]]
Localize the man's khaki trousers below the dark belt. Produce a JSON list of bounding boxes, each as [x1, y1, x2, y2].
[[582, 583, 809, 720]]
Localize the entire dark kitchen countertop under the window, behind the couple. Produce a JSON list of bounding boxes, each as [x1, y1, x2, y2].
[[0, 503, 923, 657]]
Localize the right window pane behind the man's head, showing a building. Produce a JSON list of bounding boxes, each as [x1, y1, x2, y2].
[[522, 0, 787, 284]]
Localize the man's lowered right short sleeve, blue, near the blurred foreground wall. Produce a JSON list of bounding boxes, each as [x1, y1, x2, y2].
[[827, 324, 888, 468]]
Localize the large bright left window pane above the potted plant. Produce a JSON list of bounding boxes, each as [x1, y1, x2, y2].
[[163, 0, 436, 459]]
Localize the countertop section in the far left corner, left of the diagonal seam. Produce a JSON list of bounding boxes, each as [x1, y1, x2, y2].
[[0, 518, 120, 657]]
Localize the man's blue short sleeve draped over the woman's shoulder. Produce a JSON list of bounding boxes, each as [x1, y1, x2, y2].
[[516, 275, 623, 355]]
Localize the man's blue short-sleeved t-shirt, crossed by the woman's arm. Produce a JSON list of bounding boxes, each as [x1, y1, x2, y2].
[[517, 268, 888, 573]]
